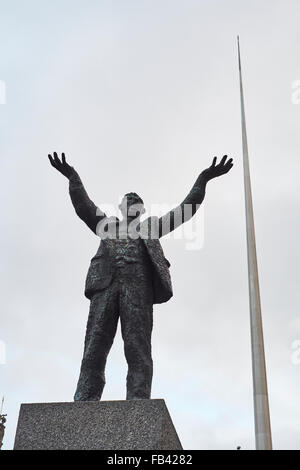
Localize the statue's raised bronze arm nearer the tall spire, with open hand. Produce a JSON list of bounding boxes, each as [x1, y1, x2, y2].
[[159, 155, 233, 237]]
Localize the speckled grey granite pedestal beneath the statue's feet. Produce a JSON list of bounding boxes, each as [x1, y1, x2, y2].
[[14, 400, 182, 450]]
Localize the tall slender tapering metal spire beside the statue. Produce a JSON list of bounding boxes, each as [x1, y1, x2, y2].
[[237, 36, 272, 450]]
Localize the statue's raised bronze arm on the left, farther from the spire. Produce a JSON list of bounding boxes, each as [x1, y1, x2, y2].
[[48, 152, 106, 233]]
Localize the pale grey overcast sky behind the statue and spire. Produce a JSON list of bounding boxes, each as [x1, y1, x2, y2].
[[0, 0, 300, 449]]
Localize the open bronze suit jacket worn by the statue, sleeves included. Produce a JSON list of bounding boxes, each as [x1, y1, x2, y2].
[[69, 170, 205, 303]]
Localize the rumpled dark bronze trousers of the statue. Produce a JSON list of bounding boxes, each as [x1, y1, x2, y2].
[[74, 265, 153, 401]]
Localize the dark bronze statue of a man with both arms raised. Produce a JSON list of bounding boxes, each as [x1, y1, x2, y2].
[[49, 152, 233, 401]]
